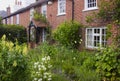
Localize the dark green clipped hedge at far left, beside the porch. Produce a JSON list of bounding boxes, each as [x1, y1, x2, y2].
[[0, 25, 27, 44]]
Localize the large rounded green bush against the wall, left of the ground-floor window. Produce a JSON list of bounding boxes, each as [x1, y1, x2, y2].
[[53, 21, 83, 48]]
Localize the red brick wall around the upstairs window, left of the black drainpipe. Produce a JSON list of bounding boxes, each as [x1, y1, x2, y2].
[[47, 0, 72, 29]]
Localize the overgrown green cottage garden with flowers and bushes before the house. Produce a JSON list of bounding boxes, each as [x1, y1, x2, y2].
[[0, 0, 120, 81]]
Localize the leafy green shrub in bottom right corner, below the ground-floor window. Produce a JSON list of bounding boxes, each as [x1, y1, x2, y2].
[[96, 47, 120, 81]]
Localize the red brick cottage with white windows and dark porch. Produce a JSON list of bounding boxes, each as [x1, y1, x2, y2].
[[3, 0, 111, 49]]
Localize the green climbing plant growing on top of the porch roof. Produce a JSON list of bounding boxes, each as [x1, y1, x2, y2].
[[34, 11, 47, 23]]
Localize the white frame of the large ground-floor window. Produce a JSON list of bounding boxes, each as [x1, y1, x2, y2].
[[85, 27, 107, 49]]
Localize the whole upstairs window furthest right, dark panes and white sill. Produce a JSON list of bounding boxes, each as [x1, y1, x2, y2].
[[84, 0, 98, 10]]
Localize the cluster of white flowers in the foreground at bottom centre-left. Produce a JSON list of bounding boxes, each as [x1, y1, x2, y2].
[[33, 56, 52, 81]]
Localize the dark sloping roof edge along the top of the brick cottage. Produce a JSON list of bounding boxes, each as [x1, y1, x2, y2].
[[3, 0, 49, 19]]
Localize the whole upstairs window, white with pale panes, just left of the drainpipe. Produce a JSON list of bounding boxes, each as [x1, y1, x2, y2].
[[58, 0, 66, 15]]
